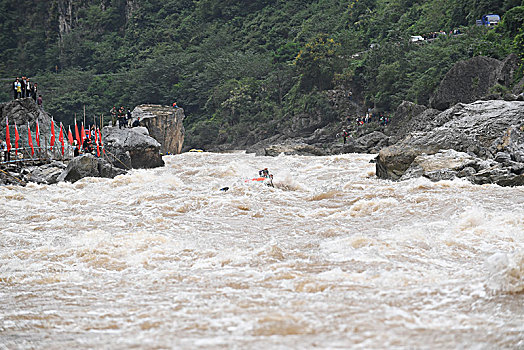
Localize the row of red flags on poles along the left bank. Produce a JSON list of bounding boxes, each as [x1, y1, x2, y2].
[[5, 117, 104, 157]]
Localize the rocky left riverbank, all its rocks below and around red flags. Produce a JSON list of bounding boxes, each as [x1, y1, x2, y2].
[[0, 99, 180, 185]]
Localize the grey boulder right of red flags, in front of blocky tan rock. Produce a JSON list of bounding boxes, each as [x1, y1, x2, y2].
[[103, 127, 164, 169]]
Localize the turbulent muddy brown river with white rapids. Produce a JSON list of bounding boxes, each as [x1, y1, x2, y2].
[[0, 153, 524, 349]]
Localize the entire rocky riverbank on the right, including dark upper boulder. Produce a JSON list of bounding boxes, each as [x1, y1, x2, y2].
[[247, 56, 524, 186]]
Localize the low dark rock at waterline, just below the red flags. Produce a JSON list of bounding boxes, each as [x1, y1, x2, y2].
[[57, 154, 125, 182]]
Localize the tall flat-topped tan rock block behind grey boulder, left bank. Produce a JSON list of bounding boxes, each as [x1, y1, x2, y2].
[[132, 105, 185, 154]]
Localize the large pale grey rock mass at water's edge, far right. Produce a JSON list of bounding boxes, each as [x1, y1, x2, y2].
[[376, 101, 524, 186]]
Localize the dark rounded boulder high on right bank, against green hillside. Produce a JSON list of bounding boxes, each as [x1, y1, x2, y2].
[[430, 55, 518, 110]]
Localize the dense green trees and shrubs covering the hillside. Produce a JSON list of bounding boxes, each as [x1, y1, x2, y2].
[[0, 0, 524, 147]]
